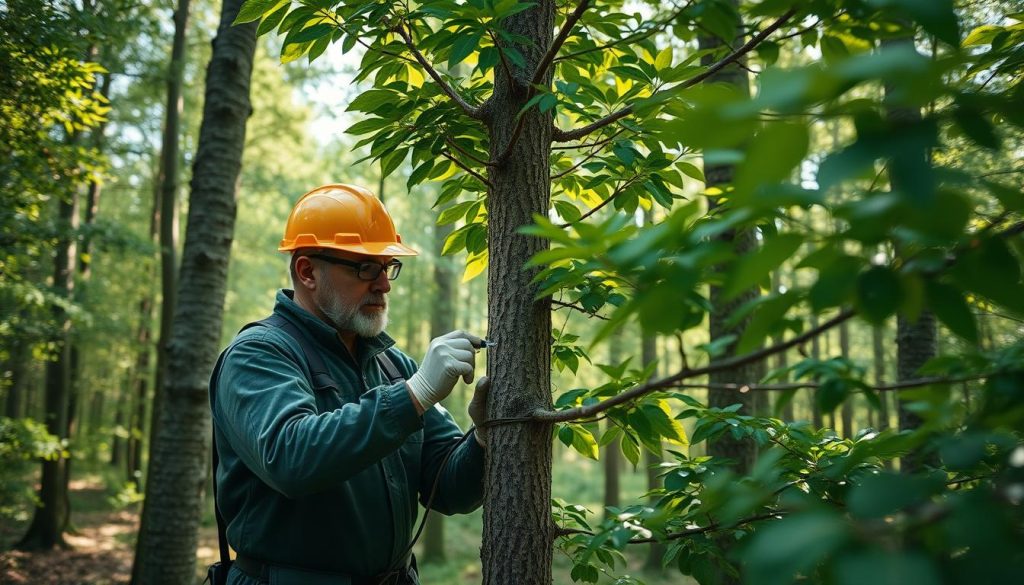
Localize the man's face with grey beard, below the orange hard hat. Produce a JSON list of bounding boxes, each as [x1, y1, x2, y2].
[[312, 250, 391, 337]]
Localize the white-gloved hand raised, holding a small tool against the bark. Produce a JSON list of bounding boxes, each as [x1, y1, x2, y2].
[[406, 331, 481, 411]]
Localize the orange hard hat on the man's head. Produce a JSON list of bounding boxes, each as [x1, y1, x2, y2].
[[278, 183, 418, 256]]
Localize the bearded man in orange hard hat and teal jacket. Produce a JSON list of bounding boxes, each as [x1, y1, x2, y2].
[[210, 184, 487, 585]]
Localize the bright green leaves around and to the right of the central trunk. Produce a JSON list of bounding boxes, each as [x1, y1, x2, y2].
[[240, 0, 1024, 583]]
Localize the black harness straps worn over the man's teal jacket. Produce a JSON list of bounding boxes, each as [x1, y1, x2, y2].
[[207, 314, 407, 585]]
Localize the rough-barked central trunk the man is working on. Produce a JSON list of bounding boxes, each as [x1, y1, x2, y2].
[[481, 0, 555, 585]]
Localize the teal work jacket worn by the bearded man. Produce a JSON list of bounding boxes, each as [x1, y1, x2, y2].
[[210, 290, 483, 583]]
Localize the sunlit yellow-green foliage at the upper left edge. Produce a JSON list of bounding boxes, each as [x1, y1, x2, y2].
[[0, 1, 109, 379]]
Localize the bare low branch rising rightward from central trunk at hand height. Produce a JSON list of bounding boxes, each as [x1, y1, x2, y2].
[[534, 309, 854, 423]]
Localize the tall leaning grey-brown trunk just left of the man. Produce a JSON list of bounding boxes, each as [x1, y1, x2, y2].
[[132, 0, 257, 585]]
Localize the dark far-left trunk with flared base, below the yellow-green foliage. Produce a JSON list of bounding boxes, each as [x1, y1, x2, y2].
[[17, 187, 78, 550]]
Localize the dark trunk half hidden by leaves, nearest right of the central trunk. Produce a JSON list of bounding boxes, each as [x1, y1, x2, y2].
[[698, 0, 764, 473]]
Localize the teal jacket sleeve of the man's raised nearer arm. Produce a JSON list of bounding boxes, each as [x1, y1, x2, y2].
[[214, 332, 423, 498]]
